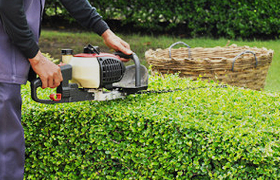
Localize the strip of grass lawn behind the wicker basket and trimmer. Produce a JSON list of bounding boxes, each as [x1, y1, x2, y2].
[[40, 30, 280, 92]]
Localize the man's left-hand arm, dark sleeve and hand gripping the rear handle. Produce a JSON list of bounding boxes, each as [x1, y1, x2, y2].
[[0, 0, 62, 88]]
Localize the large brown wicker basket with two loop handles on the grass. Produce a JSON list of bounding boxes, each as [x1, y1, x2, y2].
[[145, 42, 274, 90]]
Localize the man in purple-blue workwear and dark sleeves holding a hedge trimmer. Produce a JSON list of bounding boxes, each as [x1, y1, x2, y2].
[[0, 0, 132, 180]]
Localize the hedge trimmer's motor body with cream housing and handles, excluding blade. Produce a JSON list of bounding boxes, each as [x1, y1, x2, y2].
[[31, 45, 148, 104]]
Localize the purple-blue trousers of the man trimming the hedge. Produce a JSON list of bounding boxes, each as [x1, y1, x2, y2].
[[0, 82, 25, 180]]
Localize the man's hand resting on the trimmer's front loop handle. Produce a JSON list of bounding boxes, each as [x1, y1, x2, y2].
[[101, 29, 133, 61]]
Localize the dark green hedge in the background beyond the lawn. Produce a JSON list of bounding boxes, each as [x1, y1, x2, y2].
[[45, 0, 280, 38]]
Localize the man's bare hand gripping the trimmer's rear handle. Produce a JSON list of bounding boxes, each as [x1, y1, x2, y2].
[[29, 51, 63, 89]]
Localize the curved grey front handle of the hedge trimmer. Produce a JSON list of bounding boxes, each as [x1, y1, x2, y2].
[[114, 51, 141, 87]]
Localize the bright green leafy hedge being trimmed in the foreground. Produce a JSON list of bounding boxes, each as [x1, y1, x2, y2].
[[22, 75, 280, 180]]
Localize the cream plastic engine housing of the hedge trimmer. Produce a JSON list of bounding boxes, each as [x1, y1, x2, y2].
[[69, 57, 100, 88]]
